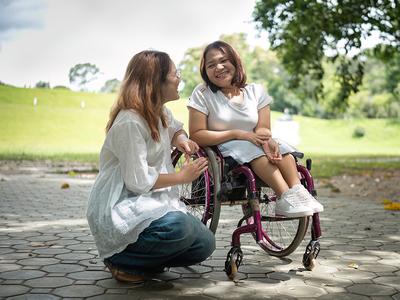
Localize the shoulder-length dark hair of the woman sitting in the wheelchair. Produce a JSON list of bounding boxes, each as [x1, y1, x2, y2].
[[200, 41, 247, 93]]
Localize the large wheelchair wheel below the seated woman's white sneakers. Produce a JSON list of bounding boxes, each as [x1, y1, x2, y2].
[[242, 187, 309, 257]]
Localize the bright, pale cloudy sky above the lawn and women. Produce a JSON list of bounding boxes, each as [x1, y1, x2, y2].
[[0, 0, 267, 86]]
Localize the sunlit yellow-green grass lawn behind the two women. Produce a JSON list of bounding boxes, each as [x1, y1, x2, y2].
[[0, 86, 400, 174]]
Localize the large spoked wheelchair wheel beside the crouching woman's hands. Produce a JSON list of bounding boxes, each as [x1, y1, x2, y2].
[[172, 150, 221, 234]]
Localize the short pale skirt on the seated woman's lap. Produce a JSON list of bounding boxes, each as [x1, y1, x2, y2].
[[218, 139, 303, 164]]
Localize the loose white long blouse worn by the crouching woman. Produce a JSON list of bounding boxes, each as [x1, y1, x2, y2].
[[87, 107, 187, 259]]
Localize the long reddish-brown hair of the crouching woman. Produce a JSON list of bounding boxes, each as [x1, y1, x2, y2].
[[106, 50, 171, 142]]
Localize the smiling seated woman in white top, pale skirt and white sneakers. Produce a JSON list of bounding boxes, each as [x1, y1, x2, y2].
[[188, 41, 323, 217]]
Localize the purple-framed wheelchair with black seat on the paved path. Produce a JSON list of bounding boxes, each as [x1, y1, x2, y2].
[[171, 147, 321, 280]]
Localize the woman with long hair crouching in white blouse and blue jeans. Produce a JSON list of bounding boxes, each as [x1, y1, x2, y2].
[[87, 51, 215, 283]]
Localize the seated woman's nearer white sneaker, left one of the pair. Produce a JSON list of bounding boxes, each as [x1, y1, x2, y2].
[[275, 189, 314, 218]]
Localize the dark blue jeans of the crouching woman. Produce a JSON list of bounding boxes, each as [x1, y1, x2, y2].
[[104, 211, 215, 275]]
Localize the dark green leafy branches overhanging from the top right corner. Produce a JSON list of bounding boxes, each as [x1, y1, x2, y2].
[[253, 0, 400, 111]]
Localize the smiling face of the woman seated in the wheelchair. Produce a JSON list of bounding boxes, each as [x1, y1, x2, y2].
[[205, 49, 236, 88]]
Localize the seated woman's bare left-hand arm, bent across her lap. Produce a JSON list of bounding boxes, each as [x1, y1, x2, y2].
[[189, 107, 263, 146]]
